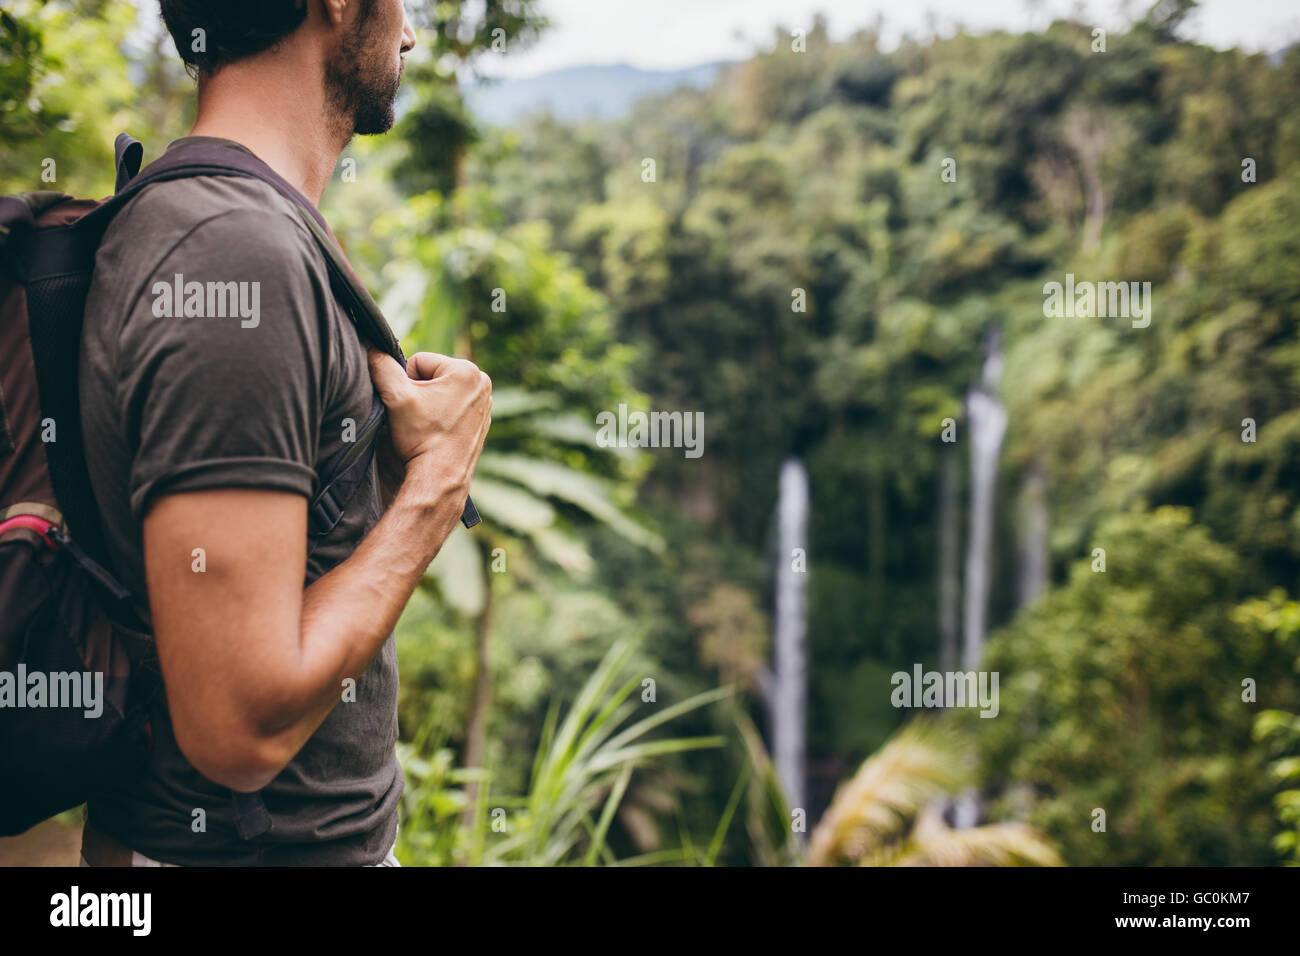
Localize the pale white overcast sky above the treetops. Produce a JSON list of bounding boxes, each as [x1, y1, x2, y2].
[[480, 0, 1300, 77]]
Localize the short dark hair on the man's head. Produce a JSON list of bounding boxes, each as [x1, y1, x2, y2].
[[159, 0, 312, 74]]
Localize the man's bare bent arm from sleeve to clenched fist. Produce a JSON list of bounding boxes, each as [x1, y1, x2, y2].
[[144, 352, 491, 791]]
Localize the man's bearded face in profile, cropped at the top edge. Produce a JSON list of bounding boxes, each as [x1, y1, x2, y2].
[[325, 0, 415, 137]]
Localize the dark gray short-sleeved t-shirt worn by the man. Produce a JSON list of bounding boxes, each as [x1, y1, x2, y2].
[[79, 137, 403, 865]]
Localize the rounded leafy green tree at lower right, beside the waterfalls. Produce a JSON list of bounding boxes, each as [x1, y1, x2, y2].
[[966, 507, 1296, 866]]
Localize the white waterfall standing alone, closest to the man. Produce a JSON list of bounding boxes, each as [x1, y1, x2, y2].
[[770, 458, 809, 843]]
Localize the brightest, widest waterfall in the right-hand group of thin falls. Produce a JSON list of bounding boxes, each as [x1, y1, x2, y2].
[[962, 329, 1006, 670]]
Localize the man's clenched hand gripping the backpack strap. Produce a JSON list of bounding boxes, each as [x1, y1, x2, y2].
[[369, 350, 491, 497]]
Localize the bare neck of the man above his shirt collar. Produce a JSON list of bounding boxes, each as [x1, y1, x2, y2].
[[190, 51, 351, 206]]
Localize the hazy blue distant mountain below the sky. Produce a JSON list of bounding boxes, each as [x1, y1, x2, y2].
[[465, 62, 727, 126]]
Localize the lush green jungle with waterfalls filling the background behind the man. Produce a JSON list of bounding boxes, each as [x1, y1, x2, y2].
[[0, 0, 1300, 866]]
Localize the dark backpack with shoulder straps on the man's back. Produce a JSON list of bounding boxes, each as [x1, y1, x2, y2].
[[0, 133, 480, 839]]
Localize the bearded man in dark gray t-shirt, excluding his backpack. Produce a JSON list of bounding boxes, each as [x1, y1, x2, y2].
[[81, 0, 491, 866]]
